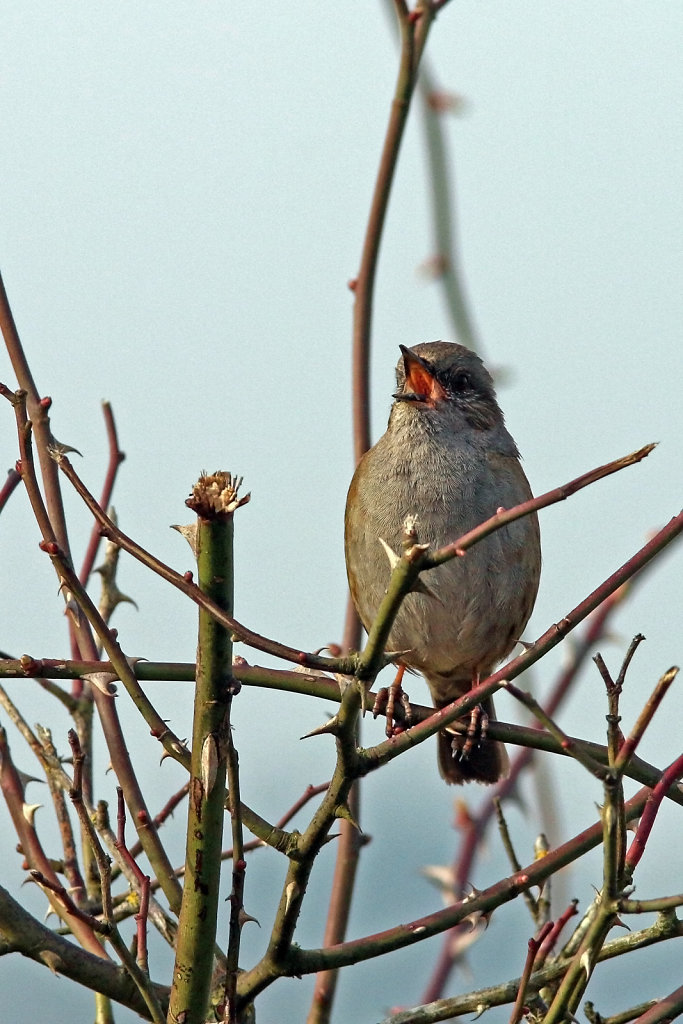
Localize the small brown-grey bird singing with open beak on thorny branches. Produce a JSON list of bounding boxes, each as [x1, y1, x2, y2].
[[344, 341, 541, 784]]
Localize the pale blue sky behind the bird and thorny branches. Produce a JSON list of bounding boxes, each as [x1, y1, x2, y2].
[[0, 0, 683, 1024]]
